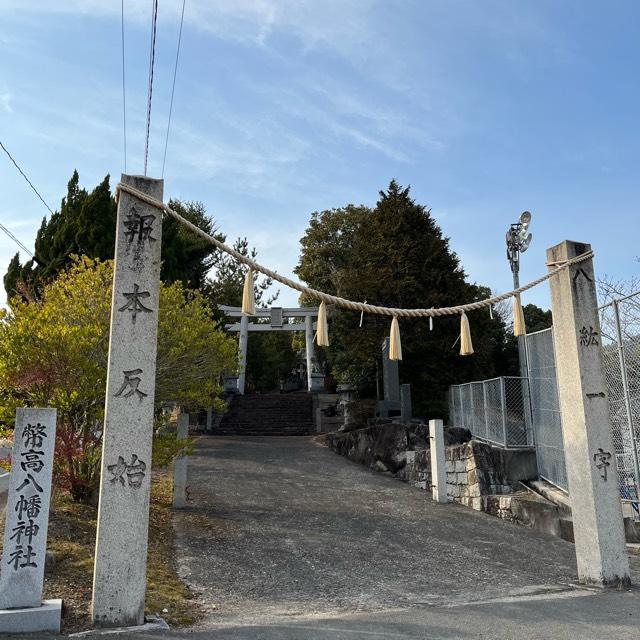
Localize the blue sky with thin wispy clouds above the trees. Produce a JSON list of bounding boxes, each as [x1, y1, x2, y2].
[[0, 0, 640, 307]]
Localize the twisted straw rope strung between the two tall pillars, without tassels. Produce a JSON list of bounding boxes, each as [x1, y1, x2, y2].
[[116, 182, 593, 318]]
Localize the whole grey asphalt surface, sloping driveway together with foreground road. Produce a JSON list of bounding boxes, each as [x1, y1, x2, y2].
[[15, 437, 640, 640]]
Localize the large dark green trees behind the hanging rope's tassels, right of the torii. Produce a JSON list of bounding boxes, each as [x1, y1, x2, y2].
[[296, 181, 506, 417]]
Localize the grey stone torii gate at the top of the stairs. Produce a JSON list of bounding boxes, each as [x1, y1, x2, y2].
[[218, 304, 324, 394]]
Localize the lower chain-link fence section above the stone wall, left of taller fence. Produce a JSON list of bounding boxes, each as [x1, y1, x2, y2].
[[449, 376, 533, 448]]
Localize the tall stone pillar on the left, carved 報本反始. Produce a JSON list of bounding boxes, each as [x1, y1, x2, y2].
[[91, 175, 163, 626]]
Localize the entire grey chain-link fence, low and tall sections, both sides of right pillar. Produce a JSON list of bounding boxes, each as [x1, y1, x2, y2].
[[449, 291, 640, 519]]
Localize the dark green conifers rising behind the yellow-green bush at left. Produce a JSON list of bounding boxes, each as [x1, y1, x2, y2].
[[4, 171, 216, 299]]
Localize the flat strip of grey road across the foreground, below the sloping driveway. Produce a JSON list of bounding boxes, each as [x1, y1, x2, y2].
[[124, 592, 640, 640]]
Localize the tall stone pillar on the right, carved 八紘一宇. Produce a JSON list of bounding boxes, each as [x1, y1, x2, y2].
[[547, 241, 630, 586]]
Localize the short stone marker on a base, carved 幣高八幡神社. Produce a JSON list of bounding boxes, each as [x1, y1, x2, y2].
[[0, 409, 62, 633]]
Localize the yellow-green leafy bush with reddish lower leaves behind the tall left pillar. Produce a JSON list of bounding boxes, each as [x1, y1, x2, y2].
[[0, 257, 237, 501]]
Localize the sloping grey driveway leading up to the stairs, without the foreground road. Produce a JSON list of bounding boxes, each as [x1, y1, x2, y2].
[[169, 437, 632, 627]]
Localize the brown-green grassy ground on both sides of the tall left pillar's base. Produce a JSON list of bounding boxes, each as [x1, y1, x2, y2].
[[14, 472, 200, 633]]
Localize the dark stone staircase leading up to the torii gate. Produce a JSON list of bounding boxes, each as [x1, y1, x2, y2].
[[213, 392, 314, 436]]
